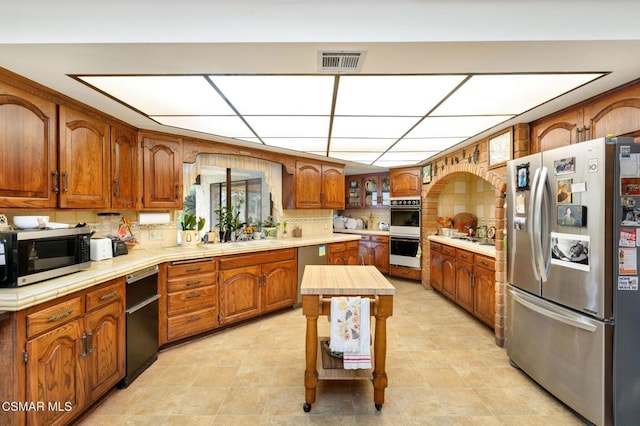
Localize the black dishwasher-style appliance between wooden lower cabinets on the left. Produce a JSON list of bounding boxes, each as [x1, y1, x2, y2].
[[118, 266, 160, 389]]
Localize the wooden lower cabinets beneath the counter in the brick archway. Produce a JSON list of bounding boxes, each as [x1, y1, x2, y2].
[[429, 242, 496, 328]]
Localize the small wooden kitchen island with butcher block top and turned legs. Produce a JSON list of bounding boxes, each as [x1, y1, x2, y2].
[[300, 265, 395, 412]]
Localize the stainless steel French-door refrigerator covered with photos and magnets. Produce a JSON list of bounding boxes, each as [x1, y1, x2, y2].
[[506, 138, 640, 425]]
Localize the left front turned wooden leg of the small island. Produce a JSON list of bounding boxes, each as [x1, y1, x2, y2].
[[302, 296, 318, 412]]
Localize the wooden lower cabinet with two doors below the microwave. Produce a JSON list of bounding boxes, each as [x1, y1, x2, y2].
[[14, 278, 126, 426]]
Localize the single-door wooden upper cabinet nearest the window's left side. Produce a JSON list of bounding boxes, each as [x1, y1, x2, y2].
[[142, 135, 183, 210]]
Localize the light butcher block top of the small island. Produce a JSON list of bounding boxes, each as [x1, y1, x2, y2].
[[300, 265, 396, 296]]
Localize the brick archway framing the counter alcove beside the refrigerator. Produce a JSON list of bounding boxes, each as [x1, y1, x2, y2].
[[421, 163, 507, 347]]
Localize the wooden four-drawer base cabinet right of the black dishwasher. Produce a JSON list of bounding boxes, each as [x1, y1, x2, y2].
[[160, 259, 218, 344]]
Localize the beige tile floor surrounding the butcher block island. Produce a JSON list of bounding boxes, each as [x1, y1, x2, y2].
[[79, 279, 583, 426]]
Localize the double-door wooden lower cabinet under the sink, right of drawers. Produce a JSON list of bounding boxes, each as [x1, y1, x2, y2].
[[219, 248, 298, 325]]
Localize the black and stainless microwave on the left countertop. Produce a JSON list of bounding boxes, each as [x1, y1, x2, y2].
[[0, 226, 92, 287]]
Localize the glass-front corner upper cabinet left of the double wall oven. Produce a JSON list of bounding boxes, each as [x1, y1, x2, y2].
[[346, 173, 391, 208]]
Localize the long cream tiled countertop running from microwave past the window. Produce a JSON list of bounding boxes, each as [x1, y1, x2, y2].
[[0, 234, 360, 314]]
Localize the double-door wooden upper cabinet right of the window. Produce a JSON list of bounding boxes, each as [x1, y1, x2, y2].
[[294, 161, 345, 209]]
